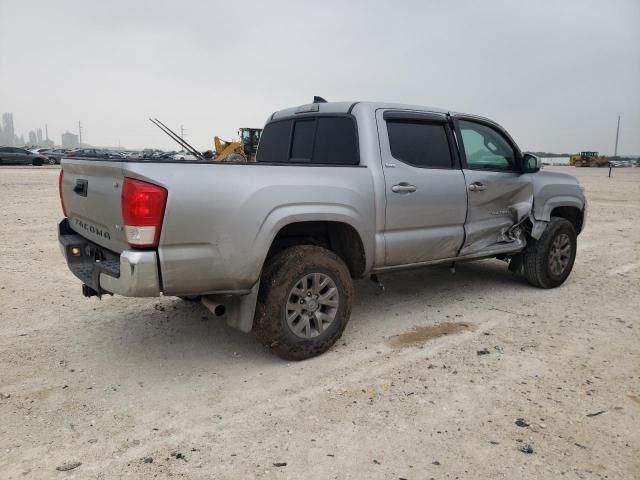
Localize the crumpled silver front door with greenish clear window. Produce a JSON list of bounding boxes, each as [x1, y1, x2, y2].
[[455, 117, 533, 255]]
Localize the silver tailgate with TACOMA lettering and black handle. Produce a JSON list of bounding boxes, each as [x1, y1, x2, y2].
[[62, 159, 128, 253]]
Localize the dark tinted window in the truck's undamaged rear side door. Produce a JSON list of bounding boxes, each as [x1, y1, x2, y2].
[[387, 120, 452, 168]]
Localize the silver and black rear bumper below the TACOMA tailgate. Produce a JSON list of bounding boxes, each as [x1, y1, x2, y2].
[[58, 218, 160, 297]]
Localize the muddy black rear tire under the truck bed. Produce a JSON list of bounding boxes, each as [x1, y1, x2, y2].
[[253, 245, 353, 360]]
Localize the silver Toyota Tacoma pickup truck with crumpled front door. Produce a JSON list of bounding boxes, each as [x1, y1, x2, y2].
[[59, 102, 586, 359]]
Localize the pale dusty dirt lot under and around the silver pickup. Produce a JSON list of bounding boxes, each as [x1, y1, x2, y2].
[[0, 167, 640, 479]]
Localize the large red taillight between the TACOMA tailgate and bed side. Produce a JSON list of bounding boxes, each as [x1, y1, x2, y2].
[[122, 178, 167, 248]]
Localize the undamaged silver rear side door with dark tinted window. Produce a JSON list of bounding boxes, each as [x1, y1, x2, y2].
[[376, 110, 467, 266]]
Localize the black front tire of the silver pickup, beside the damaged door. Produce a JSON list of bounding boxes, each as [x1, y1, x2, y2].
[[524, 217, 577, 288]]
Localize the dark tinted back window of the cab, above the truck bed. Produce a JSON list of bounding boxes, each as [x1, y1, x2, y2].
[[256, 117, 359, 165]]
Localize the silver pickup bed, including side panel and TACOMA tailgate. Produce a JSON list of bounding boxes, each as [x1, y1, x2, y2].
[[61, 159, 375, 295]]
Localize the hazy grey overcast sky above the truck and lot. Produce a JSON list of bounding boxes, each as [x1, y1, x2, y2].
[[0, 0, 640, 154]]
